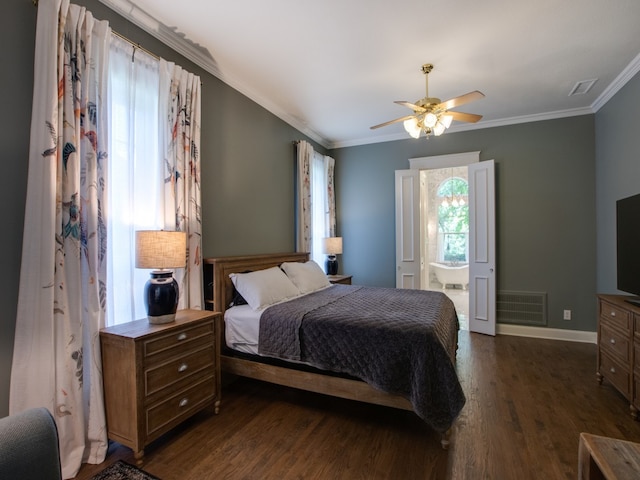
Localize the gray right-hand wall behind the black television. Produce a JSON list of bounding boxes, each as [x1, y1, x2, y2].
[[596, 71, 640, 293]]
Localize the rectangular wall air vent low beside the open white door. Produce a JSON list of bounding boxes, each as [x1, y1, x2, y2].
[[496, 291, 547, 327]]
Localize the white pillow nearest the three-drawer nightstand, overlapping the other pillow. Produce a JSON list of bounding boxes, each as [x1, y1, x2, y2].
[[229, 267, 300, 310]]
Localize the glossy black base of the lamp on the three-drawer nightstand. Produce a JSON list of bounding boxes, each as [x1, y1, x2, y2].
[[144, 270, 179, 325]]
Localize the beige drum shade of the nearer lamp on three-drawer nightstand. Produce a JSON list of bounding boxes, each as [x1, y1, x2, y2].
[[136, 230, 187, 269]]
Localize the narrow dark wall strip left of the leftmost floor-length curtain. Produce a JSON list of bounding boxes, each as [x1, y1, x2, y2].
[[0, 0, 36, 417]]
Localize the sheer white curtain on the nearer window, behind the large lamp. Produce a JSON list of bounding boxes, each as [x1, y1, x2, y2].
[[107, 35, 161, 325]]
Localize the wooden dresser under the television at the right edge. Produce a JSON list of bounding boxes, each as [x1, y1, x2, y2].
[[597, 295, 640, 419]]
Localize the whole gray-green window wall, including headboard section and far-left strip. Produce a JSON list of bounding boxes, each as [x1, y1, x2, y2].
[[0, 0, 327, 417]]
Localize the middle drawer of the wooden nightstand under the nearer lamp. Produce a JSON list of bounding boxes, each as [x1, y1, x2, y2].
[[144, 343, 215, 397]]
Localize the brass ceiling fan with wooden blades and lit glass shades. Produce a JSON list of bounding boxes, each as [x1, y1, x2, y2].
[[371, 63, 484, 138]]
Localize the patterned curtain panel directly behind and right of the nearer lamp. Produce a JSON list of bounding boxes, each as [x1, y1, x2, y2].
[[160, 59, 204, 309]]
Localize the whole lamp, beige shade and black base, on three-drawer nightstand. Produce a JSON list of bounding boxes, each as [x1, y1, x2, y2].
[[136, 230, 187, 324]]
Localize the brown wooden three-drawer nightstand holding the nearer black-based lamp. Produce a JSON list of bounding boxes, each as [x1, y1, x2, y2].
[[100, 310, 221, 464]]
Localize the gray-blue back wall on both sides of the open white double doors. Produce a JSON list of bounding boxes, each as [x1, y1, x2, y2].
[[332, 115, 596, 331]]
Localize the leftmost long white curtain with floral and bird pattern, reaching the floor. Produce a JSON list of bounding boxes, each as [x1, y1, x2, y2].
[[9, 0, 111, 478]]
